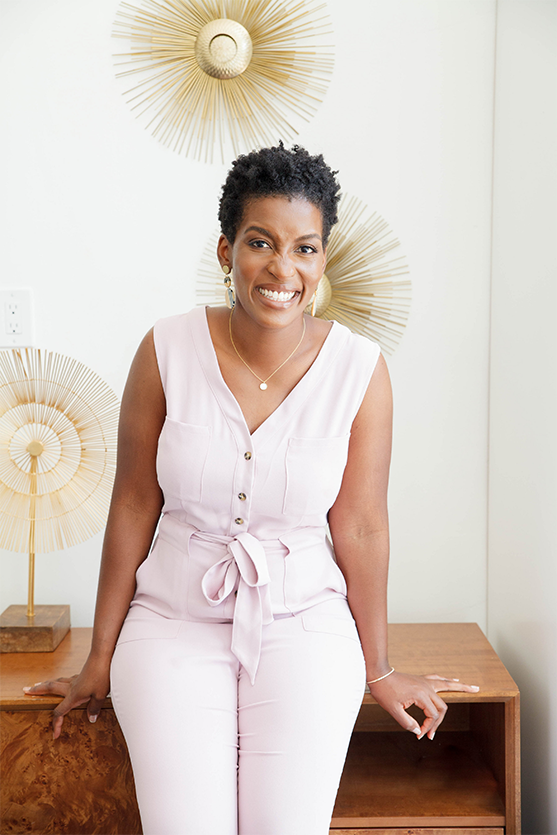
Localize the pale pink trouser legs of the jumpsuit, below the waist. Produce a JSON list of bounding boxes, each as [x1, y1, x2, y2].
[[111, 600, 365, 835]]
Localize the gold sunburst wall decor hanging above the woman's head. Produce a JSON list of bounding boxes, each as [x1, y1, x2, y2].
[[113, 0, 333, 162]]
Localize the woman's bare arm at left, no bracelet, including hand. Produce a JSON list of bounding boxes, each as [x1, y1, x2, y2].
[[26, 331, 166, 739]]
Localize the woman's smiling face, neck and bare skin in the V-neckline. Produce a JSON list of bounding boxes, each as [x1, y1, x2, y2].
[[208, 196, 331, 418]]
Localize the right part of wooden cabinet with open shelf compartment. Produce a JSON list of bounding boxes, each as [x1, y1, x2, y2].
[[331, 623, 520, 835]]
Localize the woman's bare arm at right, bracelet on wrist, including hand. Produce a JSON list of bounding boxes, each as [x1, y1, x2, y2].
[[329, 357, 477, 739]]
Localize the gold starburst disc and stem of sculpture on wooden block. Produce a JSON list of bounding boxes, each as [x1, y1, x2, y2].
[[0, 348, 118, 617]]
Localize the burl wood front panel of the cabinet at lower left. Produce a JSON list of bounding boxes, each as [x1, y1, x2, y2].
[[0, 710, 141, 835]]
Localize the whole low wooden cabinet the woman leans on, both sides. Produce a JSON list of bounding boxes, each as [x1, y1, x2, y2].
[[0, 624, 520, 835]]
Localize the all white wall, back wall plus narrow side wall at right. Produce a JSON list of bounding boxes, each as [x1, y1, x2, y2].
[[4, 0, 557, 835]]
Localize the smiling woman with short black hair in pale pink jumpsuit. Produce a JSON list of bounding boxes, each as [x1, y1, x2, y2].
[[28, 145, 474, 835]]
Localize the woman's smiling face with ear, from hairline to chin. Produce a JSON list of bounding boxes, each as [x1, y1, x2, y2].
[[218, 197, 326, 325]]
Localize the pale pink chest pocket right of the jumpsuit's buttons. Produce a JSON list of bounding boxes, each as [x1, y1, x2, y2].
[[282, 435, 350, 516]]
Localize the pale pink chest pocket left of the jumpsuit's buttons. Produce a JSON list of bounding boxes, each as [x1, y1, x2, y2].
[[157, 418, 211, 503]]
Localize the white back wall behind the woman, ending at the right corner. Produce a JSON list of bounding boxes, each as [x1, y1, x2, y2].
[[0, 0, 494, 625]]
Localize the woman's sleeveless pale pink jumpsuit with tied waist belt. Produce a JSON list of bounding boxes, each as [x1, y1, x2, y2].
[[111, 308, 379, 835]]
